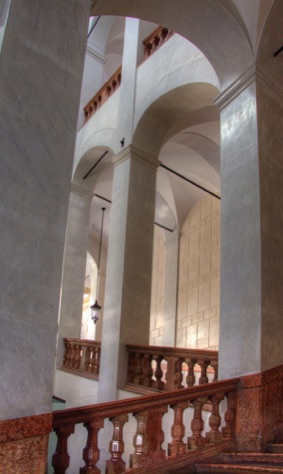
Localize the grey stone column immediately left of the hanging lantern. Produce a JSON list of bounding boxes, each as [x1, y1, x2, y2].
[[57, 184, 93, 367]]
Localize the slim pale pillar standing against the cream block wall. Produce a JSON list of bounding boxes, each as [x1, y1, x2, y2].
[[162, 231, 179, 347]]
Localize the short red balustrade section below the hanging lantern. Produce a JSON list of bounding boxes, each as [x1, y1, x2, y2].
[[62, 338, 101, 380]]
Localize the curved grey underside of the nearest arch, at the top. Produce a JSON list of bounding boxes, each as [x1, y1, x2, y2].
[[92, 0, 254, 90]]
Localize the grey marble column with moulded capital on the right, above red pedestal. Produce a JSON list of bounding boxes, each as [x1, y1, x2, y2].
[[218, 66, 283, 378]]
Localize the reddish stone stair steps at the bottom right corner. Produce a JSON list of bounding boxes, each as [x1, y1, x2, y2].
[[174, 444, 283, 474]]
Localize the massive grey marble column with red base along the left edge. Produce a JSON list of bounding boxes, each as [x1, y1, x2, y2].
[[0, 0, 89, 474]]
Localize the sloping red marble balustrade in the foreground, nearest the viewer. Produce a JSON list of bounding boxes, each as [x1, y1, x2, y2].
[[52, 379, 239, 474]]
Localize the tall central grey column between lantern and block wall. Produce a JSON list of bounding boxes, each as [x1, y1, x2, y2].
[[98, 146, 158, 402]]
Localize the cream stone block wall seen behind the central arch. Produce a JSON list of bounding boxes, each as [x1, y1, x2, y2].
[[150, 196, 220, 350]]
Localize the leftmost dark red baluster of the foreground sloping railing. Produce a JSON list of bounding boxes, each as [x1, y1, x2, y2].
[[52, 425, 75, 474]]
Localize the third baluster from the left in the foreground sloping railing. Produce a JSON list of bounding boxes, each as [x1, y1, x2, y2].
[[106, 415, 129, 474]]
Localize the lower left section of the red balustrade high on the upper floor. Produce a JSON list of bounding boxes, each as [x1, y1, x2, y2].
[[84, 66, 122, 122]]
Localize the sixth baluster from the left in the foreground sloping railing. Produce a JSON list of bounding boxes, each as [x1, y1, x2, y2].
[[168, 402, 188, 456]]
